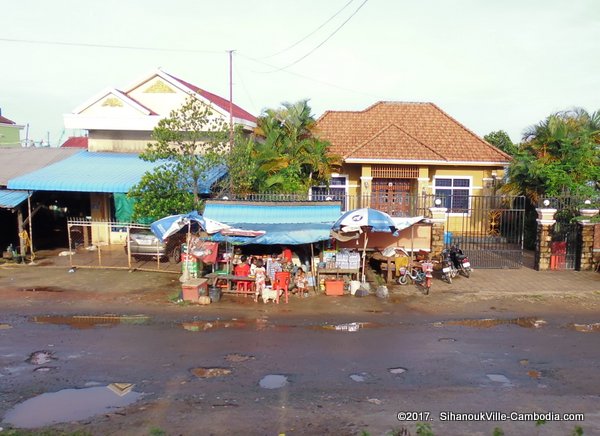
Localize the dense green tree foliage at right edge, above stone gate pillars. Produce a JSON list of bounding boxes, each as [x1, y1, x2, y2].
[[503, 109, 600, 202]]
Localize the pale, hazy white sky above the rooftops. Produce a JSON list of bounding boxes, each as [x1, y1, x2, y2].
[[0, 0, 600, 146]]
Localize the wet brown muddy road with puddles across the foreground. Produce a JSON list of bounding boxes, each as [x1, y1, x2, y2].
[[0, 260, 600, 435]]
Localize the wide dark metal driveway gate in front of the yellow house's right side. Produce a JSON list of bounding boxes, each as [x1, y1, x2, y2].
[[445, 195, 525, 269]]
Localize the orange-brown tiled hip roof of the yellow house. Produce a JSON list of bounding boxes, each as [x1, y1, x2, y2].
[[316, 101, 510, 164]]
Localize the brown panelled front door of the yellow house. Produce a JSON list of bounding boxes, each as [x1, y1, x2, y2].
[[371, 178, 410, 216]]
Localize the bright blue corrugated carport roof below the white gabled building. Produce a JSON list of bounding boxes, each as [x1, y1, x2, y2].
[[8, 151, 226, 193]]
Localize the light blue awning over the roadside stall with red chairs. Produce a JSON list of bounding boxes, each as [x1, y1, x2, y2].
[[203, 201, 341, 245]]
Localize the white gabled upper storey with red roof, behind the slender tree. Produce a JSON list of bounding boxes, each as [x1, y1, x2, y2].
[[64, 70, 256, 153]]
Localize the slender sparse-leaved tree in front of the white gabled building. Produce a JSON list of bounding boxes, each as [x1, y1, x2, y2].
[[129, 96, 228, 220]]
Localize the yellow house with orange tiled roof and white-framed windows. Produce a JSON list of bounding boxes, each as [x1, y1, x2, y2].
[[313, 101, 510, 235]]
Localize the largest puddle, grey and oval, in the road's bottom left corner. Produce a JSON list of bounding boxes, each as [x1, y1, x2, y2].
[[4, 383, 142, 428]]
